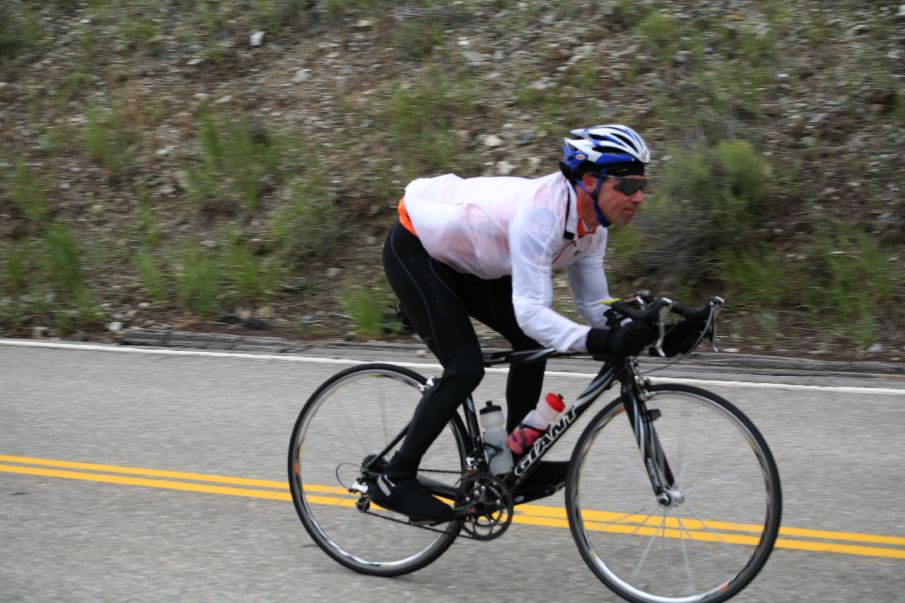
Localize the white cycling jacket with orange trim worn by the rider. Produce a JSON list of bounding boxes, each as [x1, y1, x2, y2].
[[400, 173, 609, 352]]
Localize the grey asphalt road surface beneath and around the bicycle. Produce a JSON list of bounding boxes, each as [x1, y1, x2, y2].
[[0, 341, 905, 603]]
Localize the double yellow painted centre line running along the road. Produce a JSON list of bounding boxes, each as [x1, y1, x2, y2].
[[0, 455, 905, 559]]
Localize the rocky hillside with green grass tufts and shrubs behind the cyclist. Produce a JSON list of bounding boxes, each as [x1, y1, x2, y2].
[[0, 0, 905, 360]]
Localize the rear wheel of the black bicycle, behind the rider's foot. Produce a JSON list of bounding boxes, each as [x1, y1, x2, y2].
[[289, 364, 467, 576]]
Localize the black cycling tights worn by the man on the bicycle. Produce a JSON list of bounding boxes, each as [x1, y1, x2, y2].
[[383, 222, 545, 464]]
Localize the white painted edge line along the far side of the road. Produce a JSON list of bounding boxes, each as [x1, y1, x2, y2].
[[0, 339, 905, 396]]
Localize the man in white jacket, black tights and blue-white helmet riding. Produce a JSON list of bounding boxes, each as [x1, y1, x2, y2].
[[371, 125, 656, 521]]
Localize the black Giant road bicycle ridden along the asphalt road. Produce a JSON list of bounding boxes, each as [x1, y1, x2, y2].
[[289, 296, 782, 603]]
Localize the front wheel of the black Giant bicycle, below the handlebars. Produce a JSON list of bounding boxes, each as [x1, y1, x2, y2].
[[566, 385, 782, 603]]
